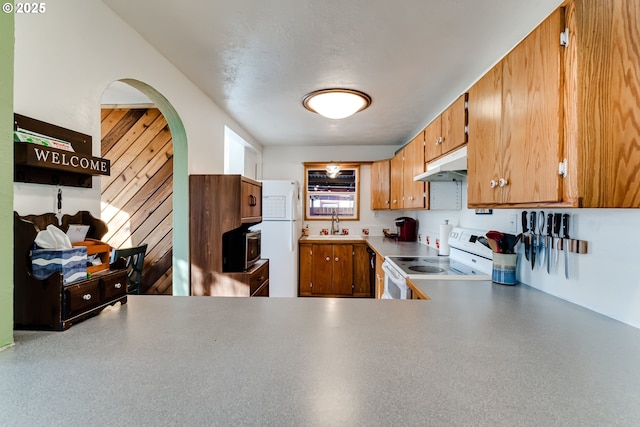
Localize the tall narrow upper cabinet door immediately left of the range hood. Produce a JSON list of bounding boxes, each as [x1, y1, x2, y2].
[[402, 132, 425, 209]]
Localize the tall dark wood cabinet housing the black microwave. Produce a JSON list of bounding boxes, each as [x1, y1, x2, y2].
[[189, 175, 269, 296]]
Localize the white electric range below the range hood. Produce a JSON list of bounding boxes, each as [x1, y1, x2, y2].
[[382, 227, 492, 299]]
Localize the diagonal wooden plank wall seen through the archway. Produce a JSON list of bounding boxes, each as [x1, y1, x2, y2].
[[101, 108, 173, 295]]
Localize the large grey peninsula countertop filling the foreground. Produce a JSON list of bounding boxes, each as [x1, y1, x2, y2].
[[0, 292, 640, 426]]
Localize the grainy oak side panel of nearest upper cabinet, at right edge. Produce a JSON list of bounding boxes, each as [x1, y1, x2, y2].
[[563, 0, 640, 208]]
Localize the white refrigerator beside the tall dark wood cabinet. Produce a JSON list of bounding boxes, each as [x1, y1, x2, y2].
[[252, 180, 302, 297]]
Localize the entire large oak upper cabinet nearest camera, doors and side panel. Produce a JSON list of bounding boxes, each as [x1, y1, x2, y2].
[[468, 0, 640, 208]]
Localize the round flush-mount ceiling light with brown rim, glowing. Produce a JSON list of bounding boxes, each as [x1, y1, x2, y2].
[[302, 89, 371, 119]]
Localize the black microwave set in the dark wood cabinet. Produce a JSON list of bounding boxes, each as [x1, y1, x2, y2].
[[222, 228, 262, 272]]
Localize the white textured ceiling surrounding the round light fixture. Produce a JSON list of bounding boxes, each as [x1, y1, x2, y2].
[[103, 0, 562, 146]]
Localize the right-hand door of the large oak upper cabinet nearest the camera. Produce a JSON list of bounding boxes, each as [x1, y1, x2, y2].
[[501, 10, 564, 203]]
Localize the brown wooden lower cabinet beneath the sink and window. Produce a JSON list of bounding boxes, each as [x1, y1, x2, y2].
[[298, 243, 371, 298]]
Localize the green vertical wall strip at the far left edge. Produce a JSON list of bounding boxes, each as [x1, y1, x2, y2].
[[0, 1, 15, 349]]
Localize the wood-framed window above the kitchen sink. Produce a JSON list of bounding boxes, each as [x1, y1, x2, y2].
[[304, 162, 360, 220]]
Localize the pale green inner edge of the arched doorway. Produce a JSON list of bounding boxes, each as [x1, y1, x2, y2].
[[103, 79, 189, 295]]
